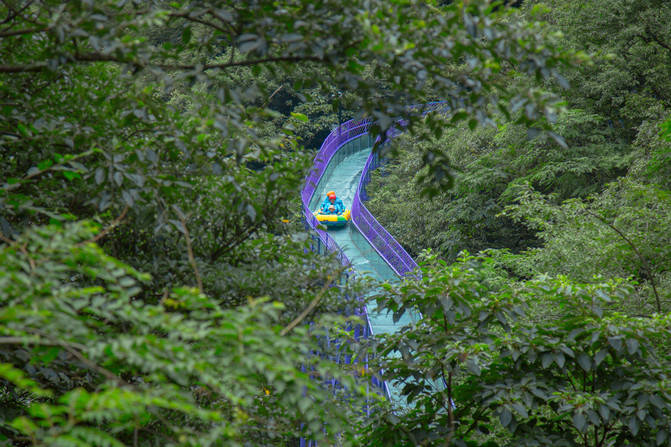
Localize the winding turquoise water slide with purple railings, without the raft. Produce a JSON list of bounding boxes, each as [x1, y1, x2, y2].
[[301, 120, 417, 406]]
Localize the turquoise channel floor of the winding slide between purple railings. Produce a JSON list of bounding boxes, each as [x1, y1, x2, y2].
[[310, 143, 413, 403]]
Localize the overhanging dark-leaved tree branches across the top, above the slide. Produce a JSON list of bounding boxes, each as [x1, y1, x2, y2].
[[0, 0, 570, 219]]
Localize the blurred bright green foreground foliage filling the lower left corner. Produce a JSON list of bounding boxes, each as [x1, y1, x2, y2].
[[0, 224, 372, 446]]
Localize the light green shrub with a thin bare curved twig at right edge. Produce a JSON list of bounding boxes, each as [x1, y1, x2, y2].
[[504, 180, 671, 315]]
